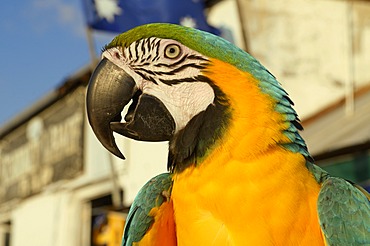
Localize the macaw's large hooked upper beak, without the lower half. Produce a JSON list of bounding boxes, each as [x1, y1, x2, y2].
[[86, 58, 137, 159]]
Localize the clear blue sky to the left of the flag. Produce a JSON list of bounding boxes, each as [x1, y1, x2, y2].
[[0, 0, 116, 127]]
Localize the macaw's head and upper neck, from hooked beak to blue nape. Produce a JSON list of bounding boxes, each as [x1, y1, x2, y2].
[[87, 24, 310, 171]]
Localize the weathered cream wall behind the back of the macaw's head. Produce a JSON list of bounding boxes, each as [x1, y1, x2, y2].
[[210, 0, 370, 118]]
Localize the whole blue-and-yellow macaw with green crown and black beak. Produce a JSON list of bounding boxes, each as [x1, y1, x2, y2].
[[87, 24, 370, 246]]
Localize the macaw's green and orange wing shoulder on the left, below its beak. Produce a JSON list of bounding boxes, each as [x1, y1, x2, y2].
[[122, 173, 176, 246]]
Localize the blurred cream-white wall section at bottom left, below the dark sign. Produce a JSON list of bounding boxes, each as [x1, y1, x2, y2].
[[11, 192, 79, 246]]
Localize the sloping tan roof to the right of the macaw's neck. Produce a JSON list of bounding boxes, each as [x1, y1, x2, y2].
[[302, 84, 370, 156]]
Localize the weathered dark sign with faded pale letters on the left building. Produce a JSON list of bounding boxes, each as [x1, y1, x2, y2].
[[0, 88, 84, 204]]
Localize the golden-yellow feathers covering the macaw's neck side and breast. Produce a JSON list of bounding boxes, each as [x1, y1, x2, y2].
[[172, 60, 323, 246]]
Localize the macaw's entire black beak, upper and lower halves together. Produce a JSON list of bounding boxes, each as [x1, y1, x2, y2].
[[86, 58, 175, 159]]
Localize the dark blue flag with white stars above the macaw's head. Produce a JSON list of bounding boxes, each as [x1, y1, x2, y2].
[[84, 0, 220, 35]]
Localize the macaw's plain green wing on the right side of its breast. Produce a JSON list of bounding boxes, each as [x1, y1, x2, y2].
[[318, 177, 370, 245]]
